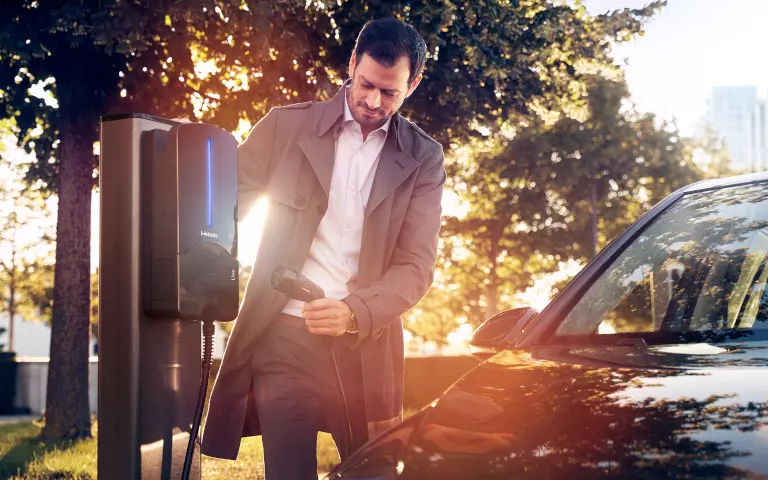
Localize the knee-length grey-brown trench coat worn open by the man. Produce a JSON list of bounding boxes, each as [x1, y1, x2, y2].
[[202, 80, 446, 459]]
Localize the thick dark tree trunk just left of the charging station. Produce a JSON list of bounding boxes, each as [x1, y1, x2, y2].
[[42, 90, 98, 439]]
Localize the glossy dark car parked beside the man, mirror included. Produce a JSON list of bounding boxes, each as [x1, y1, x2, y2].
[[330, 174, 768, 480]]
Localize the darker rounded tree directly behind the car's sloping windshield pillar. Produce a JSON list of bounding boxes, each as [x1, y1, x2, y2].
[[537, 76, 703, 260]]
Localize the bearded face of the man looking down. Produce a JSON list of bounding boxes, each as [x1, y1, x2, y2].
[[347, 55, 421, 131]]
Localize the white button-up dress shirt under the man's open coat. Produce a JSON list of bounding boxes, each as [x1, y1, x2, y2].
[[283, 89, 390, 317]]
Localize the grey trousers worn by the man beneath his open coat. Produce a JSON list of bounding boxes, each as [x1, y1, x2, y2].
[[253, 315, 350, 480]]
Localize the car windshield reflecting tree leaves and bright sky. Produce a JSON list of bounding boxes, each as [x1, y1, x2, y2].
[[555, 183, 768, 337]]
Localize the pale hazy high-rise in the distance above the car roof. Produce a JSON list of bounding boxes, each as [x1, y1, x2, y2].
[[707, 86, 768, 172]]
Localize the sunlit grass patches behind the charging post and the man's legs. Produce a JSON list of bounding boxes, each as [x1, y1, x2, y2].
[[0, 421, 339, 480]]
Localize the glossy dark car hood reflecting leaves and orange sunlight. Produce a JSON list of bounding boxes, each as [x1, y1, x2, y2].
[[331, 342, 768, 479]]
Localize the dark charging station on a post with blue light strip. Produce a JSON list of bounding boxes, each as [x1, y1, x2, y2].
[[98, 113, 239, 480]]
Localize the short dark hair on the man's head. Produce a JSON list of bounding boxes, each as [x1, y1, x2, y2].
[[355, 17, 427, 87]]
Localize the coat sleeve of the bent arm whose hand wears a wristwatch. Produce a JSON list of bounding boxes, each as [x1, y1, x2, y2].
[[343, 145, 446, 346]]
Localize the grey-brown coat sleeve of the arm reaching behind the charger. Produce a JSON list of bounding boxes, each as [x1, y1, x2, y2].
[[237, 108, 279, 221]]
